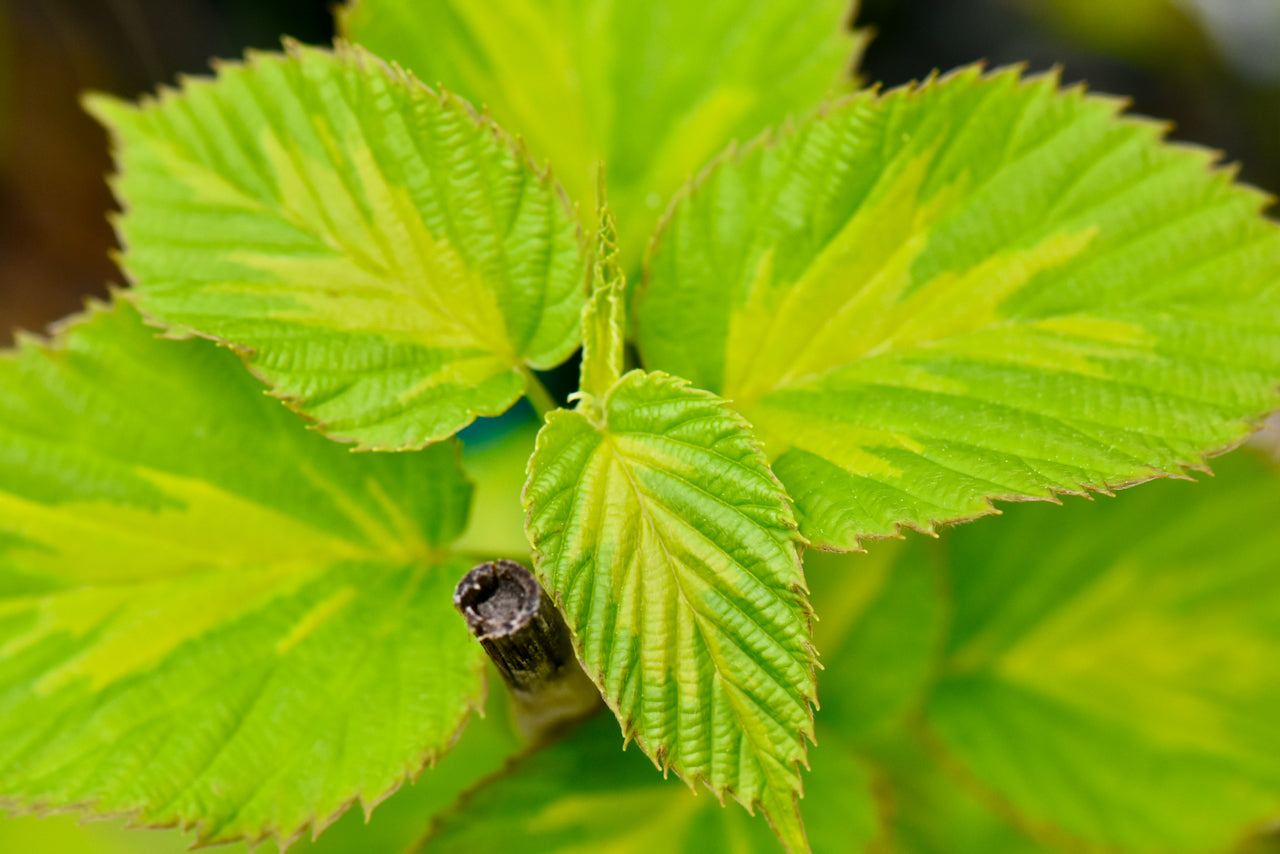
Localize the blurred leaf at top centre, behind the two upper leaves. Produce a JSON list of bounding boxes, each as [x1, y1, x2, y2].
[[338, 0, 860, 270]]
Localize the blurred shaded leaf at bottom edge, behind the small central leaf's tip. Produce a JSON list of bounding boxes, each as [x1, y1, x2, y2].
[[416, 717, 879, 854]]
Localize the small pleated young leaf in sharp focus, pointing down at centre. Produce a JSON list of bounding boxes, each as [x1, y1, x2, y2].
[[524, 371, 814, 851]]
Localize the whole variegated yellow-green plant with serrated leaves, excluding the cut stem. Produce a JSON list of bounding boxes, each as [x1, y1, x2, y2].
[[0, 0, 1280, 854]]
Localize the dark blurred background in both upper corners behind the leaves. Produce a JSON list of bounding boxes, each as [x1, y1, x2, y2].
[[0, 0, 1280, 343]]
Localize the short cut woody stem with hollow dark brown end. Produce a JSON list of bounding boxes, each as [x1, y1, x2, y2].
[[453, 561, 602, 743]]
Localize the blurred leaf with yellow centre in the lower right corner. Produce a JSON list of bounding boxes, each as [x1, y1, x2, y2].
[[928, 455, 1280, 854]]
